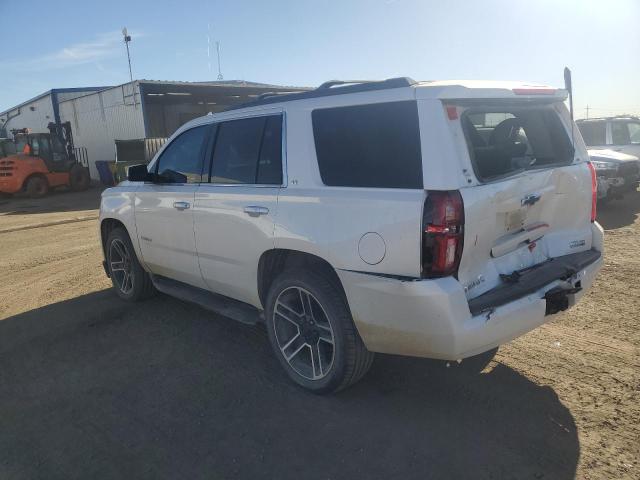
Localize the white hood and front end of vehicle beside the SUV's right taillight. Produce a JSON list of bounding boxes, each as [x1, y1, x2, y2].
[[588, 149, 640, 201]]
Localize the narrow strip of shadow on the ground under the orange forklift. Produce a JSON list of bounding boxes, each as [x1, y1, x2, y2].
[[0, 187, 103, 215]]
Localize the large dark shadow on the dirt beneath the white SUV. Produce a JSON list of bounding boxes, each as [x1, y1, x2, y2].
[[0, 291, 579, 480]]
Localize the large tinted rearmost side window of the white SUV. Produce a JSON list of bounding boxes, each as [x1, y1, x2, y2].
[[312, 101, 422, 188]]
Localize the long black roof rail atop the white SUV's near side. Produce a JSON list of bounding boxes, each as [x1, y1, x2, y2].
[[225, 77, 416, 111]]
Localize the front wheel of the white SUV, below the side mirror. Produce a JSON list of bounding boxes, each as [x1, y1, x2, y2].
[[105, 227, 156, 302]]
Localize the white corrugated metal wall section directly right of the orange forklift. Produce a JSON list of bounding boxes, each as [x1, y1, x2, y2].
[[60, 82, 145, 179]]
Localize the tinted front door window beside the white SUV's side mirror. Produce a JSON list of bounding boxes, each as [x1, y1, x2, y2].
[[156, 125, 211, 183]]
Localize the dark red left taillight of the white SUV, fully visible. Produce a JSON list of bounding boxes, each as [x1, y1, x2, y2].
[[422, 190, 464, 277]]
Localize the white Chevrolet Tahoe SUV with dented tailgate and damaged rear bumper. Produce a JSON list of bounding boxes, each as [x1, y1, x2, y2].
[[100, 78, 603, 392]]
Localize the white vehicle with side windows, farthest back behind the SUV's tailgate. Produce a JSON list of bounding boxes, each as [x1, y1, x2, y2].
[[576, 116, 640, 157]]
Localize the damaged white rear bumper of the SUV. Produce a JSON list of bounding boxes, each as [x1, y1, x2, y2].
[[338, 226, 602, 360]]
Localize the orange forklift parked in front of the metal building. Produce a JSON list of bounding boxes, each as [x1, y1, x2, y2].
[[0, 122, 90, 198]]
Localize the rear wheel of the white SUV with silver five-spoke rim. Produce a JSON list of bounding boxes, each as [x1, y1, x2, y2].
[[266, 270, 373, 393]]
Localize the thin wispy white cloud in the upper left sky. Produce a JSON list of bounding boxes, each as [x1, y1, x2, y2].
[[0, 31, 142, 72]]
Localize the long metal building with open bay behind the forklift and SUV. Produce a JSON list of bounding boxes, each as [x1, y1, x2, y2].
[[0, 80, 304, 179]]
